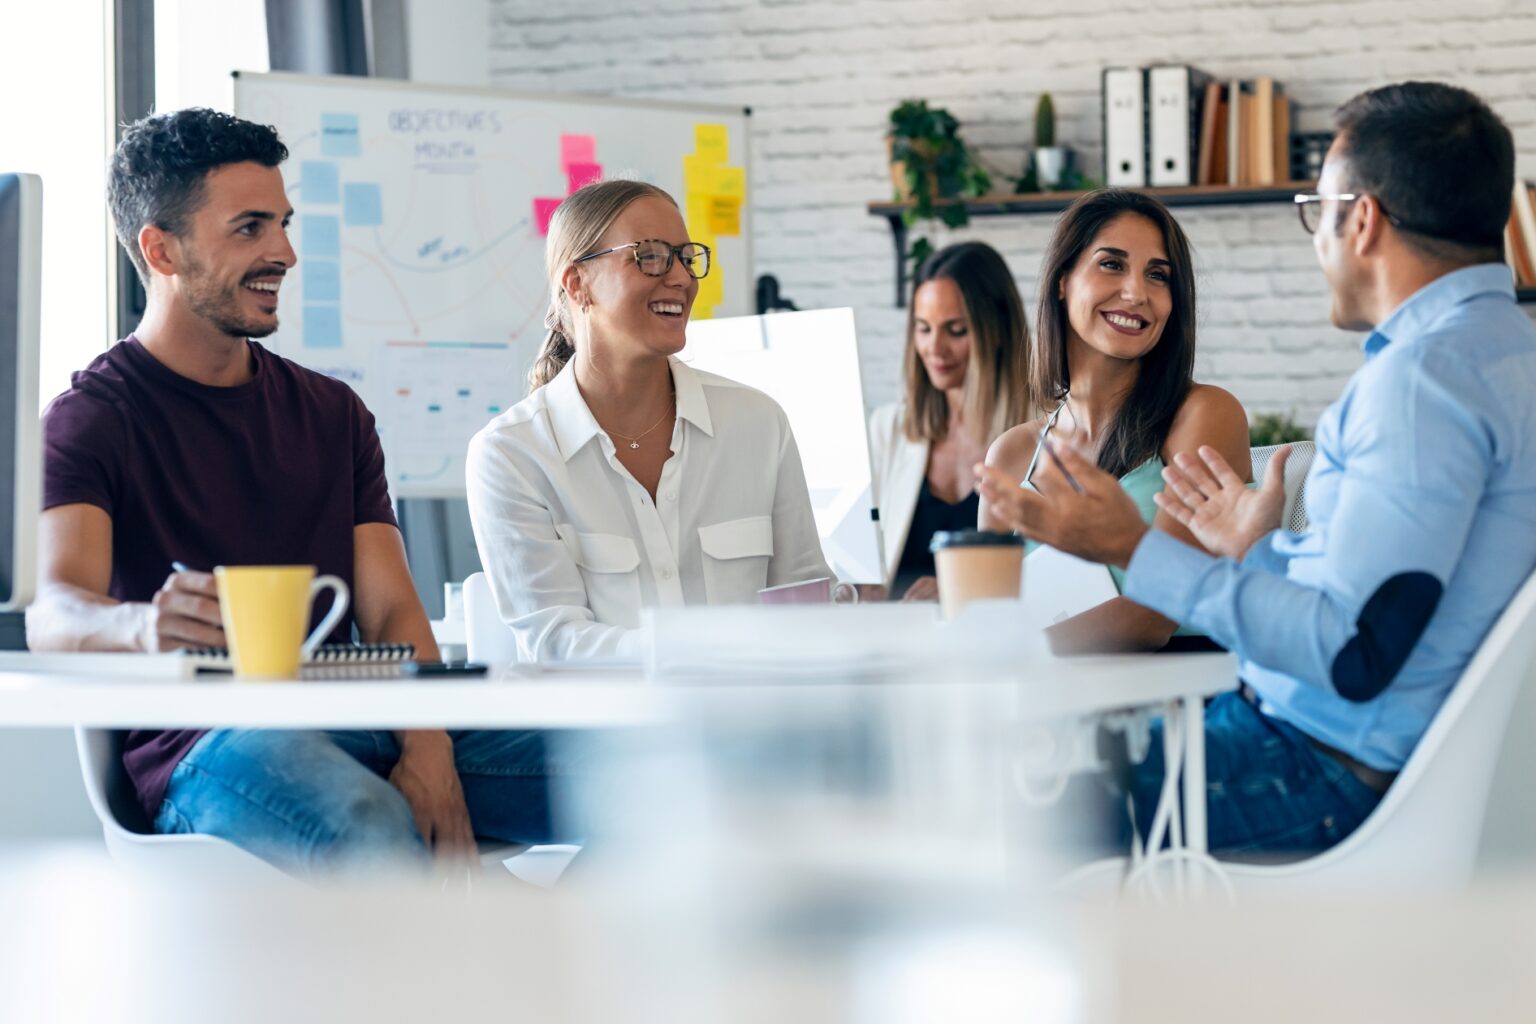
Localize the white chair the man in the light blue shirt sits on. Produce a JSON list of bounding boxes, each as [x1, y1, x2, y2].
[[1224, 574, 1536, 895]]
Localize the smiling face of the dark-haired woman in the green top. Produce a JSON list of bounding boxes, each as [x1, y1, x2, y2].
[[1061, 213, 1174, 359]]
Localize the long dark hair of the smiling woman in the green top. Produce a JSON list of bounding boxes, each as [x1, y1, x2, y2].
[[1029, 189, 1195, 476]]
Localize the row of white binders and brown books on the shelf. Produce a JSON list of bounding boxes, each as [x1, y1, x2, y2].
[[1103, 64, 1292, 187]]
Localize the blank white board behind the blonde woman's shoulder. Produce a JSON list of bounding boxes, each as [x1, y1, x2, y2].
[[679, 309, 885, 583]]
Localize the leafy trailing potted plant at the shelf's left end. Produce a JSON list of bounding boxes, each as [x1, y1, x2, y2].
[[886, 100, 992, 271]]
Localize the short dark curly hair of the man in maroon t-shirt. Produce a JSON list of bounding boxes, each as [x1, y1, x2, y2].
[[106, 107, 287, 287]]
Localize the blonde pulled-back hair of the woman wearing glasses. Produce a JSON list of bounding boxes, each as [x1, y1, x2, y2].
[[528, 178, 677, 393]]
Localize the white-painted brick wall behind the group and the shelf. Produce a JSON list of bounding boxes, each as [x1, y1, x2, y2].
[[485, 0, 1536, 422]]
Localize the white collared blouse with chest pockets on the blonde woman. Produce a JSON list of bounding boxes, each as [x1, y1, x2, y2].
[[467, 359, 831, 662]]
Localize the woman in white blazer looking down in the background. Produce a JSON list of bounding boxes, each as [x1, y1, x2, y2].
[[869, 241, 1029, 600]]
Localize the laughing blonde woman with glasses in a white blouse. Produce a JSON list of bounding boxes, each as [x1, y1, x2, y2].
[[467, 181, 831, 660]]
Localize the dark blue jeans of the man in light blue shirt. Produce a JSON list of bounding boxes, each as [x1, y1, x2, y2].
[[1126, 694, 1381, 860]]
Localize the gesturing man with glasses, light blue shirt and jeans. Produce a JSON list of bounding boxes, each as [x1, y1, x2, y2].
[[983, 83, 1536, 854]]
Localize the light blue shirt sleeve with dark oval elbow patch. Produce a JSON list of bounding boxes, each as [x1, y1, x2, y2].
[[1126, 350, 1493, 700]]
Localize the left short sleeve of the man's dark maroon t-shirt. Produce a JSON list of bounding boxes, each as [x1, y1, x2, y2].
[[43, 390, 127, 516]]
